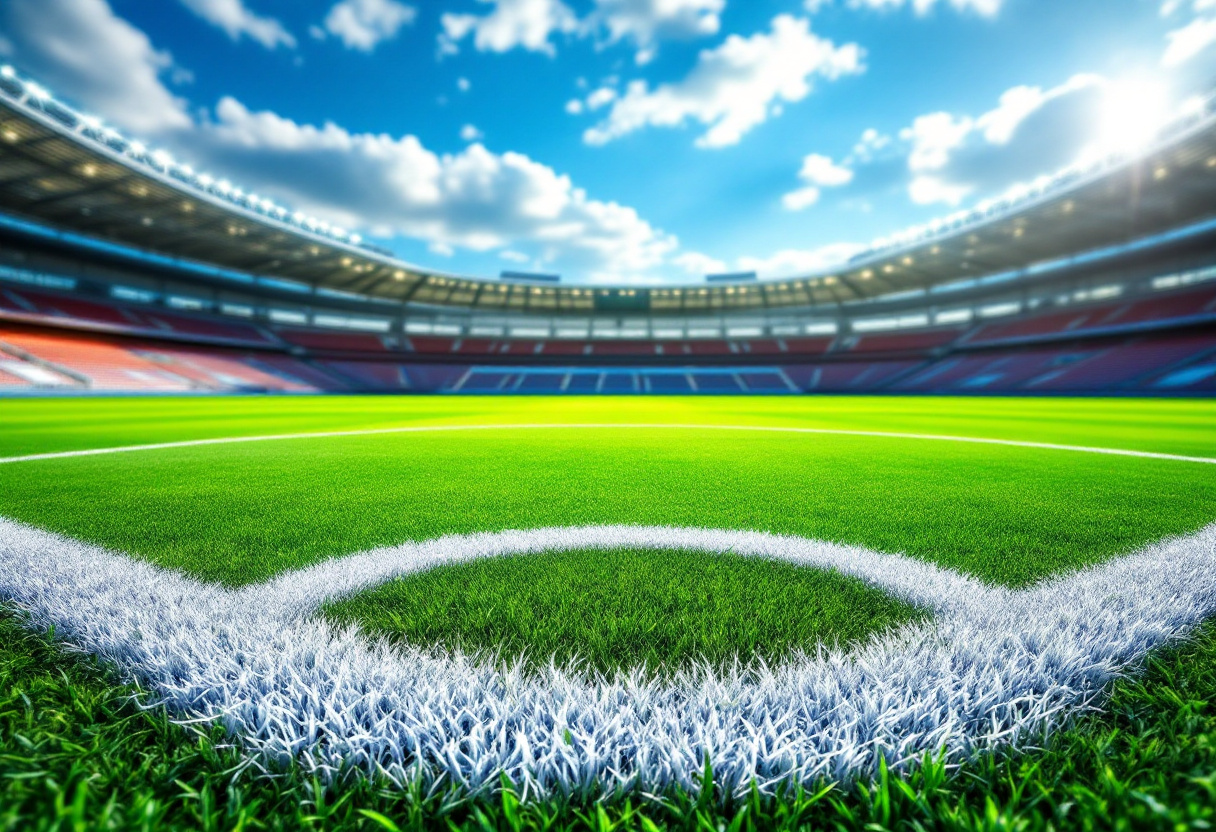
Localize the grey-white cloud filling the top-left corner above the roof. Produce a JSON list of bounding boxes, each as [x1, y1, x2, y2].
[[0, 0, 190, 134]]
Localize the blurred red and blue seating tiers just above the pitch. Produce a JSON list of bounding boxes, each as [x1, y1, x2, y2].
[[0, 276, 1216, 394]]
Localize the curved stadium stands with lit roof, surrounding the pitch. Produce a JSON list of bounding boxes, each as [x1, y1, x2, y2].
[[0, 67, 1216, 395]]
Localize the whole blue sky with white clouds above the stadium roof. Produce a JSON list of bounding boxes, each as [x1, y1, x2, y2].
[[0, 0, 1216, 283]]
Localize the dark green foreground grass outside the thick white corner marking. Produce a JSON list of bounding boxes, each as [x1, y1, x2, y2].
[[7, 603, 1216, 832]]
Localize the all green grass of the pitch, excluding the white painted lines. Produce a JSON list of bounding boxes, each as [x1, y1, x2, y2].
[[0, 398, 1216, 832]]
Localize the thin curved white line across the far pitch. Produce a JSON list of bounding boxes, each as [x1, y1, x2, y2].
[[0, 422, 1216, 465]]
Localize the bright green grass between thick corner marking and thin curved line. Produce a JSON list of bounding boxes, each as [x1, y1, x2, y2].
[[0, 429, 1216, 586]]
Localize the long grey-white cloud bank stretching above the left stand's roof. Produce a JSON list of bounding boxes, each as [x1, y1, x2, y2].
[[0, 0, 677, 279]]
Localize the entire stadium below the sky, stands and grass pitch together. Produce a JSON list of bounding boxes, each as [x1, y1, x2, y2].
[[0, 4, 1216, 831]]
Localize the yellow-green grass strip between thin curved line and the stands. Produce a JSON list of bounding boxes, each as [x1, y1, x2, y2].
[[0, 397, 1216, 457]]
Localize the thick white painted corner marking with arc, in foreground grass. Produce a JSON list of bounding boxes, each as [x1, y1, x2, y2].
[[0, 518, 1216, 796]]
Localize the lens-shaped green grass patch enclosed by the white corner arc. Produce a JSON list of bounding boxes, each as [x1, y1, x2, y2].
[[325, 550, 919, 673]]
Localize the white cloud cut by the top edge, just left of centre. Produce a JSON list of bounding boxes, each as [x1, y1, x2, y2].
[[439, 0, 579, 56]]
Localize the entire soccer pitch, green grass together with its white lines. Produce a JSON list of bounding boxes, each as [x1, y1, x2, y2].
[[0, 397, 1216, 828]]
